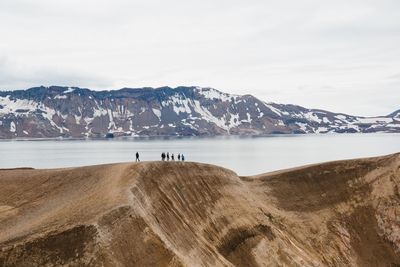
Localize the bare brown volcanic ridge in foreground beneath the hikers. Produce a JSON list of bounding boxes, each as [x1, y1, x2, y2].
[[0, 154, 400, 267]]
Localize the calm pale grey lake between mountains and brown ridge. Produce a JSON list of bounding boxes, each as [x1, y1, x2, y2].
[[0, 134, 400, 175]]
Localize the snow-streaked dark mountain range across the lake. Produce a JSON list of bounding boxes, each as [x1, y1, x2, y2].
[[0, 86, 400, 138]]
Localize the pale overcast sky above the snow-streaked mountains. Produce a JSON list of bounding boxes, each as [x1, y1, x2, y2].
[[0, 0, 400, 116]]
